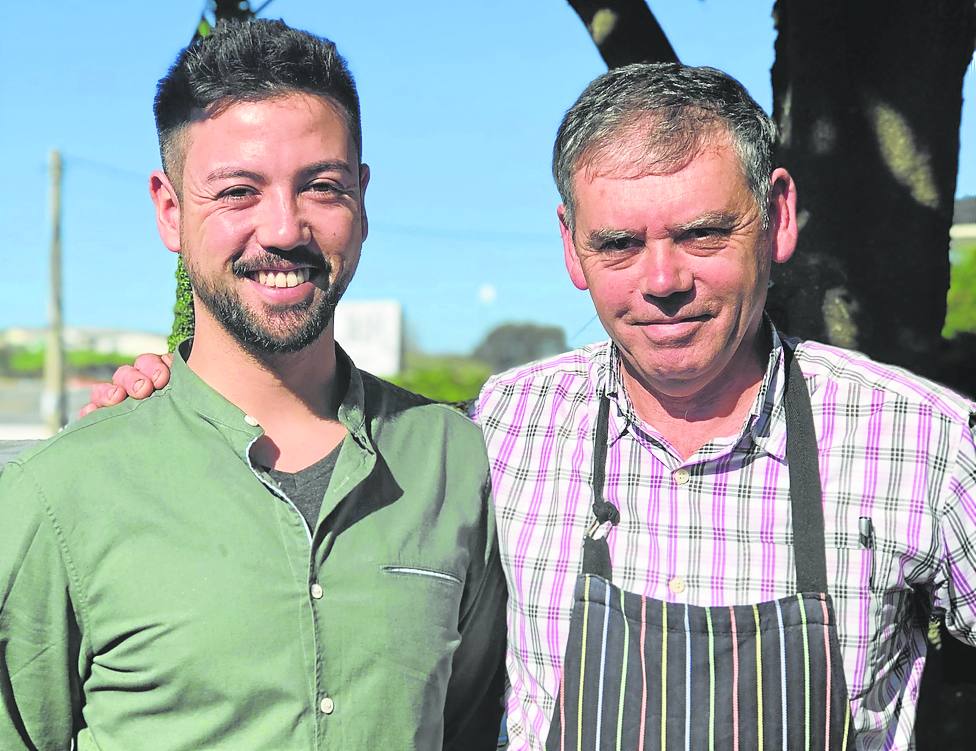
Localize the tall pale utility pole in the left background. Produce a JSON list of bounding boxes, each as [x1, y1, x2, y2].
[[41, 149, 68, 435]]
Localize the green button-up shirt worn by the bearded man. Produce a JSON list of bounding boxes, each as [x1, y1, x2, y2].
[[0, 351, 505, 751]]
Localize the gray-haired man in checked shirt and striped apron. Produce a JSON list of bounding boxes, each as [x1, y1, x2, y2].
[[86, 65, 976, 750]]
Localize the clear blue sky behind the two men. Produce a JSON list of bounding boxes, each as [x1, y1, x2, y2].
[[0, 0, 976, 352]]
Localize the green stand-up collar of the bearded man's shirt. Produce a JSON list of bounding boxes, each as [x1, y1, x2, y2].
[[167, 337, 374, 452]]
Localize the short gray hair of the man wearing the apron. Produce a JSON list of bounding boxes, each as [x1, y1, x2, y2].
[[552, 63, 776, 230]]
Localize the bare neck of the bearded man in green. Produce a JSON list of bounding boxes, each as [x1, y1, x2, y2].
[[187, 316, 345, 471]]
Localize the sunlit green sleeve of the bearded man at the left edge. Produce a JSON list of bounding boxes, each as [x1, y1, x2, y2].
[[0, 463, 81, 751]]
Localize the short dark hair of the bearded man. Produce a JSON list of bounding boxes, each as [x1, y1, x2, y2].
[[153, 19, 363, 189]]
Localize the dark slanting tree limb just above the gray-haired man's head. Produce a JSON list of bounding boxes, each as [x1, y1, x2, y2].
[[568, 0, 678, 68]]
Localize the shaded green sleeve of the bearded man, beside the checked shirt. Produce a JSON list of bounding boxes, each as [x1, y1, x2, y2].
[[444, 480, 507, 751]]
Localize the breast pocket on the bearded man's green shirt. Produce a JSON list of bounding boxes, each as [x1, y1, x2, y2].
[[362, 562, 464, 681]]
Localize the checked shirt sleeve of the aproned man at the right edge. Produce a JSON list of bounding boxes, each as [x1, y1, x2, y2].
[[935, 420, 976, 646]]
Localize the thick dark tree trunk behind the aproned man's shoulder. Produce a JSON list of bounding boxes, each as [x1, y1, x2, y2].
[[770, 0, 976, 377]]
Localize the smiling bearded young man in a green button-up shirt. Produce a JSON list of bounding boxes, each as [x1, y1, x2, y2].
[[0, 22, 505, 751]]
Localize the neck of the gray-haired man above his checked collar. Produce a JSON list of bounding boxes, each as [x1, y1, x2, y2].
[[621, 331, 769, 459]]
